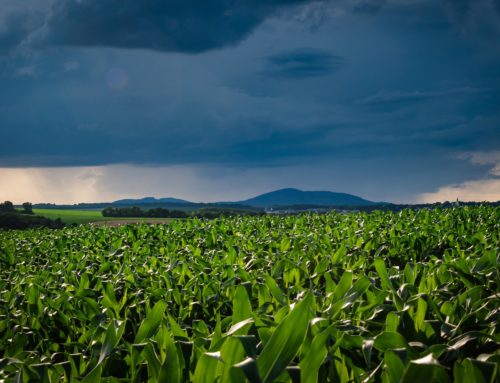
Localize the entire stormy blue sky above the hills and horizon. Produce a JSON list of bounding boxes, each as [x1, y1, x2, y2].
[[0, 0, 500, 203]]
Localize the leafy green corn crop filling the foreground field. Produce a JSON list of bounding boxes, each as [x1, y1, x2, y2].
[[0, 206, 500, 383]]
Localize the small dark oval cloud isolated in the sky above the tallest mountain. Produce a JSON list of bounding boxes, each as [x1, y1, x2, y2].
[[263, 48, 344, 79]]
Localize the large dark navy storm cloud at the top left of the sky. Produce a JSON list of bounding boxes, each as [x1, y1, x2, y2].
[[30, 0, 306, 53]]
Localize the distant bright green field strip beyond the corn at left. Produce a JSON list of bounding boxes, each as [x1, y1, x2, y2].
[[33, 209, 170, 224]]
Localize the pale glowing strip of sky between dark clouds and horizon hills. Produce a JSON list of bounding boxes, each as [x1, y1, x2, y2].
[[0, 165, 500, 205]]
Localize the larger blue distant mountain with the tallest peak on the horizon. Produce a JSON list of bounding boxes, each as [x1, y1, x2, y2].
[[238, 188, 376, 207]]
